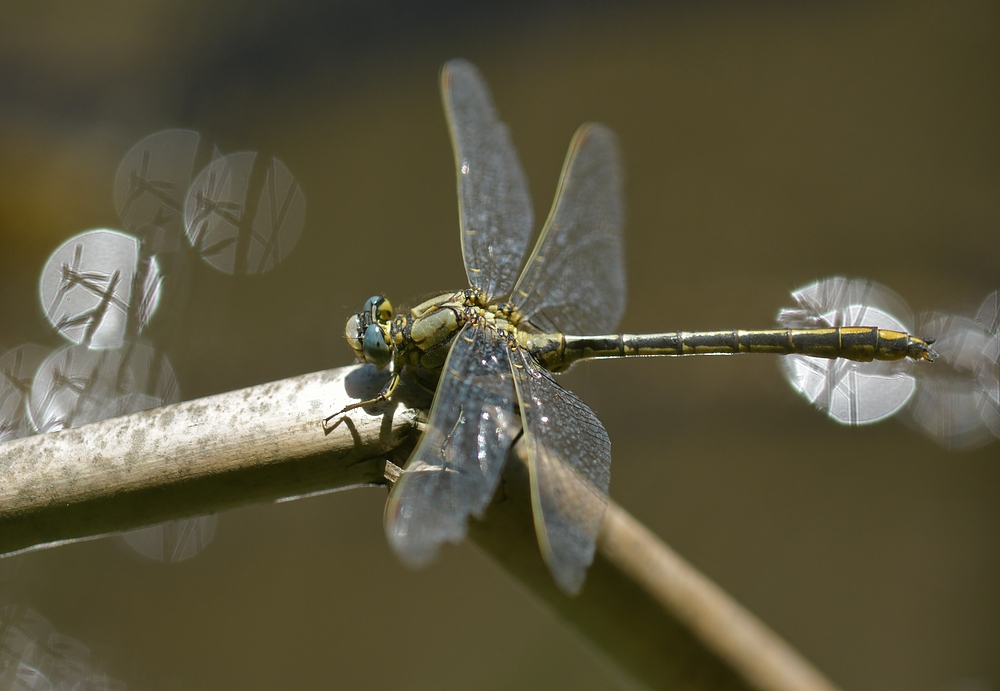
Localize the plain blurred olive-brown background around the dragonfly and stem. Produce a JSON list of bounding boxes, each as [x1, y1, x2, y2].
[[0, 0, 1000, 691]]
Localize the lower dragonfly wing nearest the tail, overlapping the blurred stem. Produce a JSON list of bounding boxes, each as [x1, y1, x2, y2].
[[514, 351, 611, 595]]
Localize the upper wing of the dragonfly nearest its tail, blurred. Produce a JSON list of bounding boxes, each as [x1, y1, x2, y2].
[[511, 124, 625, 334]]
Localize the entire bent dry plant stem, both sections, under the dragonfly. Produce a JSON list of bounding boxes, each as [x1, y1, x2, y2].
[[0, 367, 834, 691]]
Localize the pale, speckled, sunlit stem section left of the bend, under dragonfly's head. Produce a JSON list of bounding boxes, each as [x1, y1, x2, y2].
[[0, 367, 421, 554]]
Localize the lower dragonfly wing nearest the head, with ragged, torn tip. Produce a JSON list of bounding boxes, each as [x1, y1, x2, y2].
[[385, 325, 520, 566]]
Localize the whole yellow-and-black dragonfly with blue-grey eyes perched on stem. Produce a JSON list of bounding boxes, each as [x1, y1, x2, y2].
[[332, 60, 935, 595]]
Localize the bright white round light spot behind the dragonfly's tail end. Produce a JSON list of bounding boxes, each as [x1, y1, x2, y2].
[[778, 278, 916, 425]]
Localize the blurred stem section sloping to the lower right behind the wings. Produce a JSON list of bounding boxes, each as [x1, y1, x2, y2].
[[470, 445, 837, 691]]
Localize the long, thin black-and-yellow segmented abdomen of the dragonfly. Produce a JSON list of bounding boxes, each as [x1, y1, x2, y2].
[[523, 326, 934, 371]]
